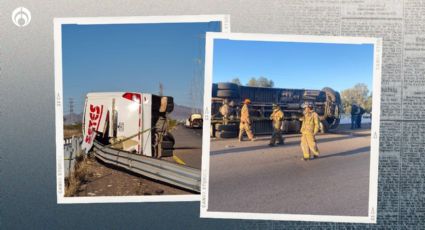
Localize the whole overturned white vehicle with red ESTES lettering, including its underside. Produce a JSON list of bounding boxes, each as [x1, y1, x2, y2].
[[82, 92, 175, 158]]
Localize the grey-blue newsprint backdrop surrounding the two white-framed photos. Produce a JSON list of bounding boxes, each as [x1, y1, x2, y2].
[[0, 0, 425, 229]]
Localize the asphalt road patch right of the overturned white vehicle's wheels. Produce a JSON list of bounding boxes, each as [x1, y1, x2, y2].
[[168, 125, 202, 169]]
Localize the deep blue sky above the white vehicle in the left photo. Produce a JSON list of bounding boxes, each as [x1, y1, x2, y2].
[[62, 22, 220, 114]]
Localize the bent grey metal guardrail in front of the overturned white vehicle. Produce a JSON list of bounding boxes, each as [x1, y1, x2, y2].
[[93, 142, 201, 192]]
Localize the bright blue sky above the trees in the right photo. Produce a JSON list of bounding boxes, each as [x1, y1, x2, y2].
[[213, 39, 373, 91]]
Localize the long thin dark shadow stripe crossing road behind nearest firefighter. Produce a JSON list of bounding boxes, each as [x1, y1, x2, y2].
[[210, 133, 370, 156]]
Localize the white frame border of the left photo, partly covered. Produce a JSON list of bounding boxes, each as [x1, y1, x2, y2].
[[53, 15, 230, 204]]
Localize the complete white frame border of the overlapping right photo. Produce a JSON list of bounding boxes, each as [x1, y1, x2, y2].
[[200, 32, 382, 223]]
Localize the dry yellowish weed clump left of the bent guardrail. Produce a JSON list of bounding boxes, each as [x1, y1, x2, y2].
[[65, 154, 89, 196]]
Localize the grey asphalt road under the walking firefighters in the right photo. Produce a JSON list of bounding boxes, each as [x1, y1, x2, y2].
[[208, 126, 370, 216]]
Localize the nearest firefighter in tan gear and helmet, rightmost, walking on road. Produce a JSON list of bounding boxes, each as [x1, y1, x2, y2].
[[301, 103, 319, 161]]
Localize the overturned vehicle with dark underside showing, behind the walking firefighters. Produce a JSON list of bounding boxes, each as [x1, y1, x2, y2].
[[210, 82, 342, 138]]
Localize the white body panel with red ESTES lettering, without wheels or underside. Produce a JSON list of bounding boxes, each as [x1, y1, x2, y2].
[[82, 92, 171, 157]]
